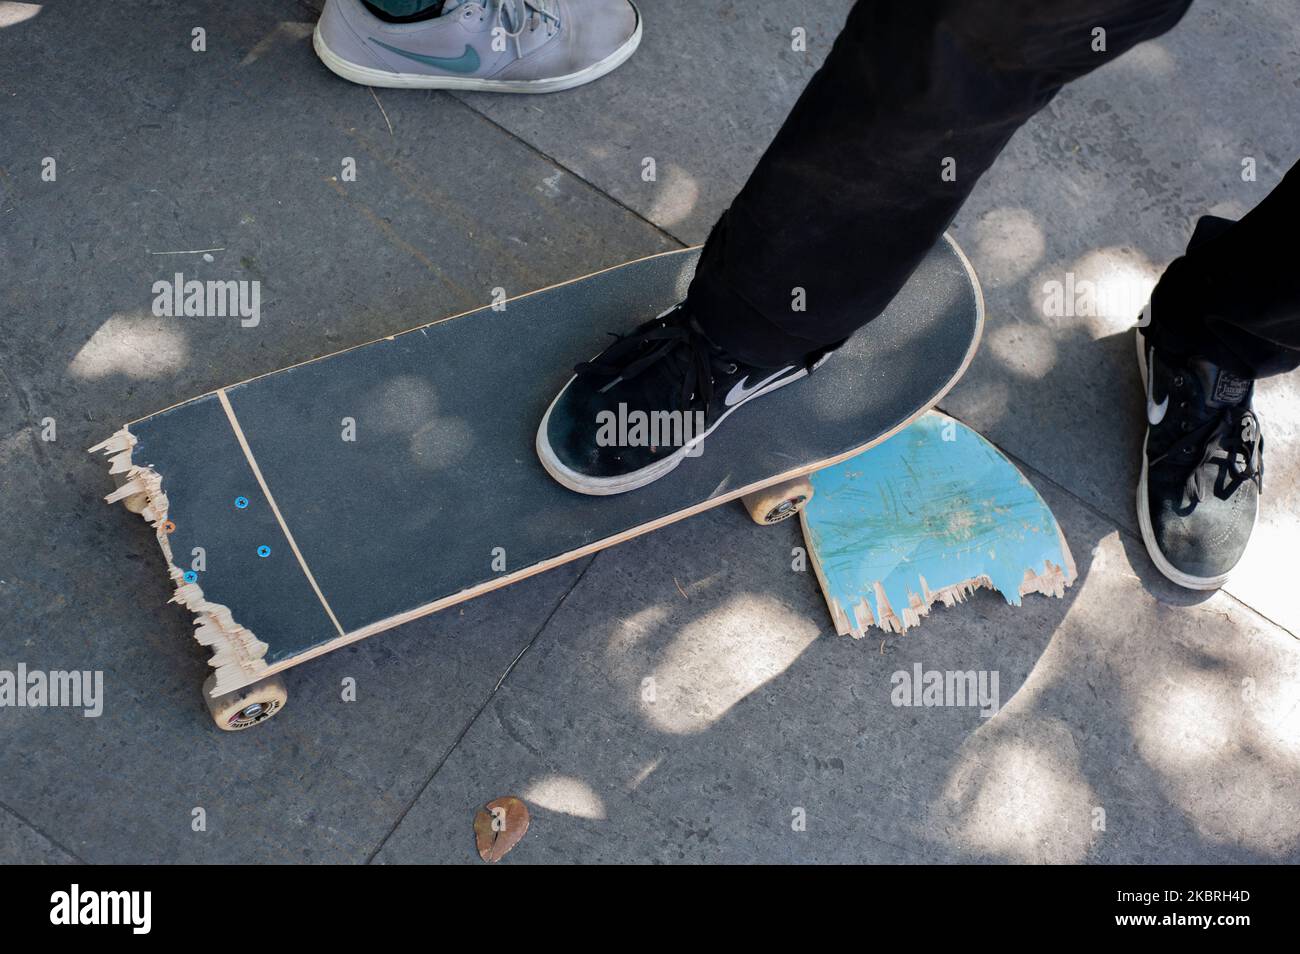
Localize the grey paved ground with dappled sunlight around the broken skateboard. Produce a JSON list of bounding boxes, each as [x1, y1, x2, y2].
[[0, 0, 1300, 863]]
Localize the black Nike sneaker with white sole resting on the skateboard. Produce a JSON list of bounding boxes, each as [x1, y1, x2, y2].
[[537, 304, 829, 494]]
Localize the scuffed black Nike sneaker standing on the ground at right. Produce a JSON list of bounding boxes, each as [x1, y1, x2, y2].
[[1138, 328, 1264, 590]]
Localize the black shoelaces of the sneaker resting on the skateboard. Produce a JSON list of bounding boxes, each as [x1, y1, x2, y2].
[[573, 310, 714, 411]]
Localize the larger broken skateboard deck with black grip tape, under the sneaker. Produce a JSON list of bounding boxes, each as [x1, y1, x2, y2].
[[92, 237, 983, 727]]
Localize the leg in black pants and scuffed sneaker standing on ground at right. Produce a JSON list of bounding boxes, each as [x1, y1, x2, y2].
[[1138, 164, 1300, 589]]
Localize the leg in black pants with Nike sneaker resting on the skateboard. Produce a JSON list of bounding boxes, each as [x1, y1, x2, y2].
[[537, 0, 1191, 494]]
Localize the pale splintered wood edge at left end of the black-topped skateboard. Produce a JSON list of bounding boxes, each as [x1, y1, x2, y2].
[[90, 428, 268, 697]]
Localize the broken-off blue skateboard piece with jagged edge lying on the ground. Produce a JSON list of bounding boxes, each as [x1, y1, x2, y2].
[[800, 411, 1076, 637]]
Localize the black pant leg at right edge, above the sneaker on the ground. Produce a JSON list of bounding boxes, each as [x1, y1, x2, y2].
[[1147, 162, 1300, 378]]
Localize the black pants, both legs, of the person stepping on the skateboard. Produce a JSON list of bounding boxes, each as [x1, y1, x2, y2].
[[689, 0, 1300, 377]]
